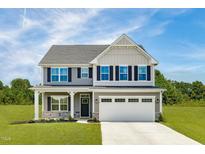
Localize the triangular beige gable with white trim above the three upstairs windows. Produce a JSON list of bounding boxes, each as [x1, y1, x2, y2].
[[90, 34, 158, 65]]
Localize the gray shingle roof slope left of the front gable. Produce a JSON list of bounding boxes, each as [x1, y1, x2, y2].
[[39, 45, 109, 65]]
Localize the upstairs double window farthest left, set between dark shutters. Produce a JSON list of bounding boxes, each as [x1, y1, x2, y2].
[[51, 68, 68, 82]]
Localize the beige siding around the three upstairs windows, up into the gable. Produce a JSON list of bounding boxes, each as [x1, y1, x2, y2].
[[93, 46, 155, 86]]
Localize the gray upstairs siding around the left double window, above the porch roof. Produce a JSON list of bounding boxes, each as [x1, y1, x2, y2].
[[43, 67, 93, 85]]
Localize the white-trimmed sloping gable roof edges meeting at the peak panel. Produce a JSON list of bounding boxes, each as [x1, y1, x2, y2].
[[90, 34, 158, 65]]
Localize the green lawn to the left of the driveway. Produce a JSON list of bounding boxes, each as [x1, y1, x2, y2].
[[0, 105, 102, 144]]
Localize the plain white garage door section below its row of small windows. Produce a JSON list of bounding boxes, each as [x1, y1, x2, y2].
[[99, 96, 155, 121]]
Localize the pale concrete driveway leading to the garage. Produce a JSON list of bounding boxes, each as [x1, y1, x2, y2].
[[101, 122, 200, 145]]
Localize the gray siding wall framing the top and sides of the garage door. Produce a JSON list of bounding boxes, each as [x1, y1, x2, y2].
[[94, 92, 160, 119]]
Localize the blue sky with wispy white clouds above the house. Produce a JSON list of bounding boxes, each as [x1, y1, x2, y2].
[[0, 9, 205, 84]]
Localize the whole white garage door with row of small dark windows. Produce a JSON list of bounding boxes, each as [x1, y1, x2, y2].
[[99, 96, 155, 121]]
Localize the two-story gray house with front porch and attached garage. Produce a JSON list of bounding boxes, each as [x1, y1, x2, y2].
[[32, 34, 164, 121]]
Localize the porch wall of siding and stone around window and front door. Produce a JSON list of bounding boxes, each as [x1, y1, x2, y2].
[[42, 92, 92, 118]]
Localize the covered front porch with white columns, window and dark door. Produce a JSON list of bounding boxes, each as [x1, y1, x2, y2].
[[34, 87, 94, 120]]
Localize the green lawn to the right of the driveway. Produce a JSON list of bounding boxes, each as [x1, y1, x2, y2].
[[163, 106, 205, 144]]
